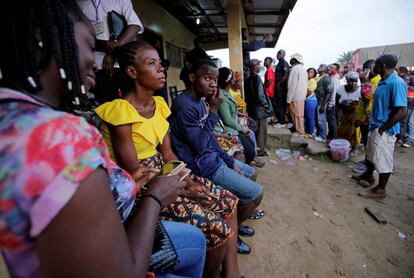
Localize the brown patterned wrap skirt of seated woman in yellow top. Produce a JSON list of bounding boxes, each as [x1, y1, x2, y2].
[[140, 153, 239, 249]]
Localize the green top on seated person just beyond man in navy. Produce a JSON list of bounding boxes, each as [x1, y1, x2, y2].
[[218, 90, 248, 135]]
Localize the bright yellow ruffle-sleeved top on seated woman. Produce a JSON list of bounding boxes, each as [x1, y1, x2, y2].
[[95, 97, 171, 161]]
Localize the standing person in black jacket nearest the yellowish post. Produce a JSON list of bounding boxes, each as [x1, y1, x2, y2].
[[244, 59, 273, 156]]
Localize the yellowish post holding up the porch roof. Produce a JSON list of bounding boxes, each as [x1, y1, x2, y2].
[[227, 0, 244, 98]]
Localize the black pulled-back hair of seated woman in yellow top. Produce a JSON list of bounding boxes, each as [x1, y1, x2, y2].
[[115, 39, 153, 94]]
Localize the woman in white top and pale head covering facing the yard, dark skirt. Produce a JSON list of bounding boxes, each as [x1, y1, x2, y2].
[[337, 71, 361, 151]]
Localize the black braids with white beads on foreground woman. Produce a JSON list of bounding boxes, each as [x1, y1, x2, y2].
[[0, 0, 89, 111]]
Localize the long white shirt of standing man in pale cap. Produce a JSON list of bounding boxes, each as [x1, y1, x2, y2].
[[286, 64, 308, 103]]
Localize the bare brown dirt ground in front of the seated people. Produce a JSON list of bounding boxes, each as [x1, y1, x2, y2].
[[239, 148, 414, 278]]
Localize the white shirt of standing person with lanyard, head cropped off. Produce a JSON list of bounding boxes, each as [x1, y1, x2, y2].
[[78, 0, 144, 69]]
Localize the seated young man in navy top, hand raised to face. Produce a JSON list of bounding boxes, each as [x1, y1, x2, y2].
[[171, 60, 263, 254]]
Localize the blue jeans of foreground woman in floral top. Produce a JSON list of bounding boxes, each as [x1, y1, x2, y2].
[[155, 221, 206, 278]]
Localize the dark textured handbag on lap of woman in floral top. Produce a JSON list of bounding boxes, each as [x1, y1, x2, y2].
[[149, 221, 180, 273]]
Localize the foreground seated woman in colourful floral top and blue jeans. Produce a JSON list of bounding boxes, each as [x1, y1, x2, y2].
[[0, 0, 205, 277]]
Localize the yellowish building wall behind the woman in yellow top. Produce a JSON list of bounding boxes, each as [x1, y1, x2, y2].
[[132, 0, 195, 94]]
